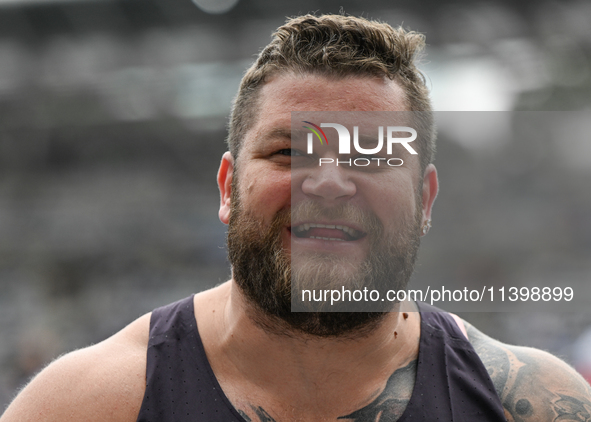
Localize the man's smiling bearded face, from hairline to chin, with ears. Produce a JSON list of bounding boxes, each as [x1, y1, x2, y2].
[[220, 75, 437, 335]]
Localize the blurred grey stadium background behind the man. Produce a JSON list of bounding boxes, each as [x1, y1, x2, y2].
[[0, 0, 591, 409]]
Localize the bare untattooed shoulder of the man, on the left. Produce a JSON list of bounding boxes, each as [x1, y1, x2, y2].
[[0, 314, 150, 422]]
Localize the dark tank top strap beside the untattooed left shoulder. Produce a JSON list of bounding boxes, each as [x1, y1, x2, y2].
[[137, 296, 245, 422]]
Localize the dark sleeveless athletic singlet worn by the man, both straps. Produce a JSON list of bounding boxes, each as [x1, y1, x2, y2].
[[137, 296, 506, 422]]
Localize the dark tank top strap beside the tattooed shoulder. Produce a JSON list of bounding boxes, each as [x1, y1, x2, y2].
[[399, 302, 506, 422]]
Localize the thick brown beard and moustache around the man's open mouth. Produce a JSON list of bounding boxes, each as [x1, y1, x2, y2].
[[228, 180, 421, 338]]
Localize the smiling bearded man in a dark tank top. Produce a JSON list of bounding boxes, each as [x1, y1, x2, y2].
[[1, 15, 591, 422]]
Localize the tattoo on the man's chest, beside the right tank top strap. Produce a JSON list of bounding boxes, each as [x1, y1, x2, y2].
[[338, 360, 417, 422]]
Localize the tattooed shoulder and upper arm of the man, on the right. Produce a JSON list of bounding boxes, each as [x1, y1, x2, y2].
[[464, 322, 591, 422]]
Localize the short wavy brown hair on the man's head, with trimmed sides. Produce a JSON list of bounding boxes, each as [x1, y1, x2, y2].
[[228, 15, 435, 169]]
